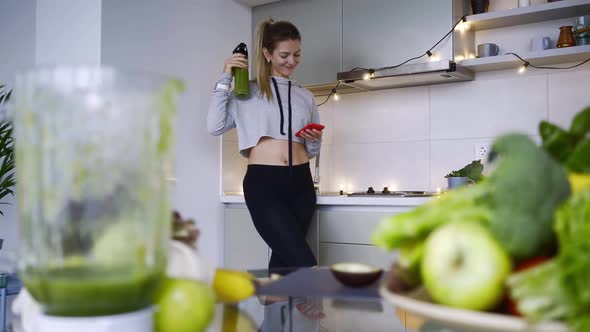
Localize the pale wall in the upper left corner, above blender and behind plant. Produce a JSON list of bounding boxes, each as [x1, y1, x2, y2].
[[0, 0, 100, 252]]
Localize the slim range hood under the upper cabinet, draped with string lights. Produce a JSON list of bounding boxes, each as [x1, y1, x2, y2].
[[337, 60, 474, 91]]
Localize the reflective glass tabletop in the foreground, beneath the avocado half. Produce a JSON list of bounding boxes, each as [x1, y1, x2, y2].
[[9, 268, 512, 332]]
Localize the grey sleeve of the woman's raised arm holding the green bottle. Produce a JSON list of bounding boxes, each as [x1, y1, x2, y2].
[[207, 74, 236, 136]]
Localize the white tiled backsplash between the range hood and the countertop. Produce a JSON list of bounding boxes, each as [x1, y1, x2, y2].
[[221, 64, 590, 192]]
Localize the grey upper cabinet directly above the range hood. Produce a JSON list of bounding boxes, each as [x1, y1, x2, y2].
[[342, 0, 455, 71]]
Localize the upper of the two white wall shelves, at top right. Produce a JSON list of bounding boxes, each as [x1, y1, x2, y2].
[[467, 0, 590, 31]]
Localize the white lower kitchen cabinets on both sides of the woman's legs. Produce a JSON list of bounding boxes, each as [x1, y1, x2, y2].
[[224, 204, 415, 270]]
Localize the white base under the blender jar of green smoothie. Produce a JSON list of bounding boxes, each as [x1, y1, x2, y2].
[[34, 307, 154, 332]]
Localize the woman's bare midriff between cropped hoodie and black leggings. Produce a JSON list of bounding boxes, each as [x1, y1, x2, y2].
[[248, 137, 309, 166]]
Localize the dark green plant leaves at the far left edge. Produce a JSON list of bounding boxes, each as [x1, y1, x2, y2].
[[0, 84, 15, 249]]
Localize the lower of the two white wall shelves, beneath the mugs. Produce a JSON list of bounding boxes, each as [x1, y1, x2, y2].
[[458, 45, 590, 72]]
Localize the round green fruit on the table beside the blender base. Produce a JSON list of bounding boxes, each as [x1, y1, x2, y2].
[[154, 278, 215, 332]]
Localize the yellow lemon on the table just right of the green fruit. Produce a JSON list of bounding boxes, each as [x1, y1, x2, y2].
[[213, 269, 255, 303]]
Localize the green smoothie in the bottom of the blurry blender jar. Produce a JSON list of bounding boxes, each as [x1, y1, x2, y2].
[[23, 266, 165, 317]]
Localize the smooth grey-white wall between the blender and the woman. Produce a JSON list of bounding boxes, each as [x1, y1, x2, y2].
[[102, 0, 252, 263]]
